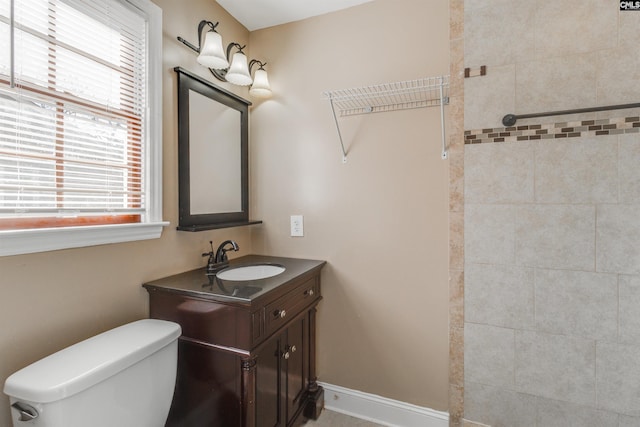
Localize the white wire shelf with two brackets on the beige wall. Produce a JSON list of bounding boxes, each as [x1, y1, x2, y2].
[[323, 76, 450, 163]]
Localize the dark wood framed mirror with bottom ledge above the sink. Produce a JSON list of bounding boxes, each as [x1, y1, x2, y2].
[[174, 67, 262, 231]]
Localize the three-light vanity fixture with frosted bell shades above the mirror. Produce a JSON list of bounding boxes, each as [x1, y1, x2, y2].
[[178, 20, 271, 98]]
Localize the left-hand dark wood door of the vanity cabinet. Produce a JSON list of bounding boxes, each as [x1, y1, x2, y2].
[[256, 335, 285, 427]]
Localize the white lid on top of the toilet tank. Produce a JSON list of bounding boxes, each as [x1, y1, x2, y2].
[[4, 319, 182, 403]]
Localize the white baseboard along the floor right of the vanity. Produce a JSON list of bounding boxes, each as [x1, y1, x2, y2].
[[318, 382, 449, 427]]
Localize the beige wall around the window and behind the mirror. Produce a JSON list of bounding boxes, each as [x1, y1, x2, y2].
[[0, 0, 253, 426]]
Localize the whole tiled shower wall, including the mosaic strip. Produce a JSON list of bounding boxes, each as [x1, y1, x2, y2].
[[464, 0, 640, 427]]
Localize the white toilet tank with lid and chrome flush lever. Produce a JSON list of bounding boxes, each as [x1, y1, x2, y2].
[[4, 319, 182, 427]]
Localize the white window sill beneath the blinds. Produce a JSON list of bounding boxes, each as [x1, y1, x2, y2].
[[0, 222, 169, 256]]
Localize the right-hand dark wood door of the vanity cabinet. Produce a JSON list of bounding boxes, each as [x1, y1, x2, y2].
[[284, 317, 307, 423]]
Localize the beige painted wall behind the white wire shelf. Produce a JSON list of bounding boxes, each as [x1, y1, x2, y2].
[[250, 0, 449, 410]]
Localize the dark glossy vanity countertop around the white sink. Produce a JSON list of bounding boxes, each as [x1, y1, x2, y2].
[[142, 255, 326, 303]]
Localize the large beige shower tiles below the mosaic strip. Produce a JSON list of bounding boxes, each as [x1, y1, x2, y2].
[[465, 134, 640, 427]]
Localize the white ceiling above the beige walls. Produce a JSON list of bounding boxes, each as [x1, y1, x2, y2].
[[216, 0, 372, 31]]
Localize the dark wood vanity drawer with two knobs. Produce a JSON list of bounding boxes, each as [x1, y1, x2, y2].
[[265, 277, 320, 335]]
